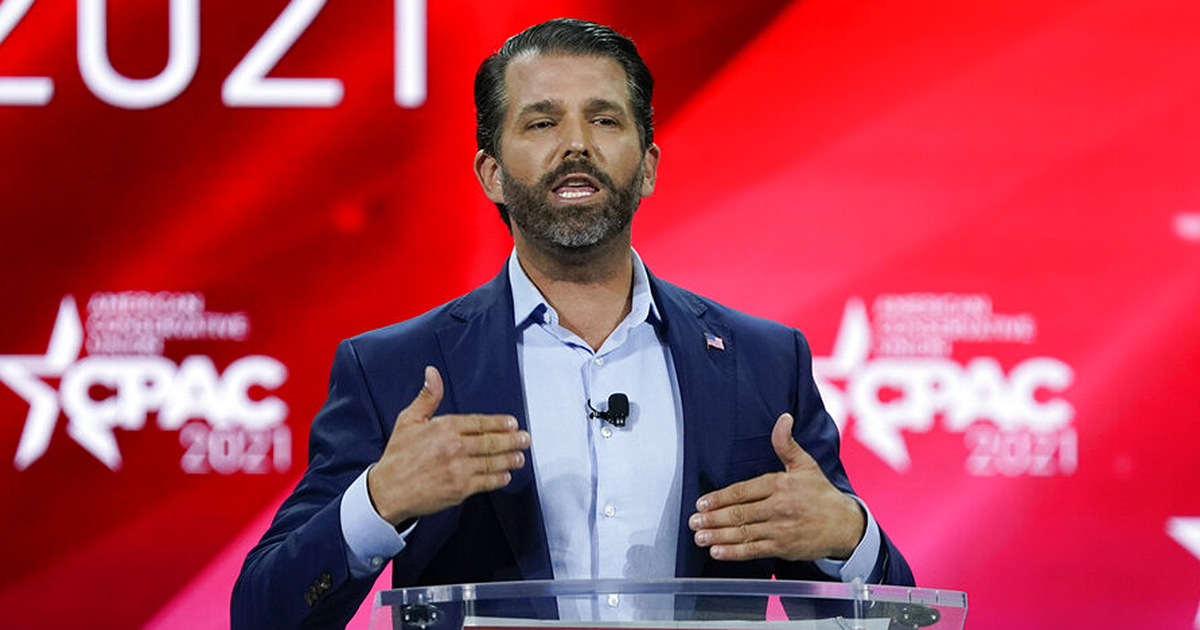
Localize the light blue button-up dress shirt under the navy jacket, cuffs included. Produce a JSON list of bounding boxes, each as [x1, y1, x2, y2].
[[340, 251, 881, 597]]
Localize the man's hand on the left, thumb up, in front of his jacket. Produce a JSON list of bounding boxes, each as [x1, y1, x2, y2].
[[367, 366, 529, 524]]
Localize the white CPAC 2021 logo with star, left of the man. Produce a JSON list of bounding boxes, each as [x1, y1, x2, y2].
[[0, 293, 290, 473]]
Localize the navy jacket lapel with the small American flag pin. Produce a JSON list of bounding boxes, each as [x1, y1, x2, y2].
[[650, 276, 737, 577]]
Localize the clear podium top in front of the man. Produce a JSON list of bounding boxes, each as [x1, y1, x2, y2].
[[371, 578, 967, 630]]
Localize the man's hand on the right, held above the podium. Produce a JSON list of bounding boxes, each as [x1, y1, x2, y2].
[[688, 414, 866, 560]]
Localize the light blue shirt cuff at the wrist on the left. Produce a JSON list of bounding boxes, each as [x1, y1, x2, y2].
[[340, 467, 415, 580]]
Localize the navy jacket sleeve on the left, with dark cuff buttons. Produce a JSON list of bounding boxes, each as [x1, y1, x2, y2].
[[230, 340, 386, 630]]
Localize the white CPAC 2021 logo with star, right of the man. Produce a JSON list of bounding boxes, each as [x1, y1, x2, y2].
[[814, 294, 1078, 476]]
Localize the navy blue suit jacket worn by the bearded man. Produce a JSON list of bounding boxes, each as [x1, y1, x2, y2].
[[232, 262, 913, 630]]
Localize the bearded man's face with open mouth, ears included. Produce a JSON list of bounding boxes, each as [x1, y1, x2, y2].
[[475, 55, 659, 250]]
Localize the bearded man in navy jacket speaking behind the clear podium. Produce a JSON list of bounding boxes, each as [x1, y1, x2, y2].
[[232, 19, 912, 628]]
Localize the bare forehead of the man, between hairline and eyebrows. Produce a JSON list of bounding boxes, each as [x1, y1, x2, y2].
[[504, 54, 629, 115]]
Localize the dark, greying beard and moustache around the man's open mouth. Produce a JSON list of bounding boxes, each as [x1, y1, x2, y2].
[[500, 160, 644, 251]]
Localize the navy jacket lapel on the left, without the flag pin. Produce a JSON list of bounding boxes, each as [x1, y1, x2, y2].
[[437, 265, 553, 580]]
